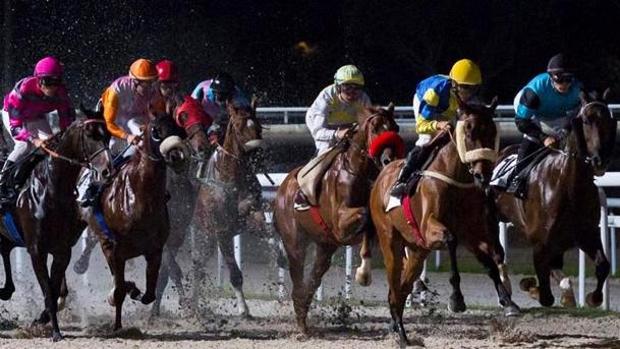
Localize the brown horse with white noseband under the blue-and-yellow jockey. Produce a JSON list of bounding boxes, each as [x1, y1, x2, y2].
[[370, 101, 516, 346]]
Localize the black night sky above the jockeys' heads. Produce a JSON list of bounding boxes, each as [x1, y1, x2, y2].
[[2, 0, 620, 106]]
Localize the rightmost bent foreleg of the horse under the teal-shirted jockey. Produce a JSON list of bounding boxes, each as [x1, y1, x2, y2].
[[577, 232, 611, 307]]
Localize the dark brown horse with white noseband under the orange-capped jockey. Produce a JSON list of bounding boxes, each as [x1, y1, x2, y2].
[[82, 110, 187, 330]]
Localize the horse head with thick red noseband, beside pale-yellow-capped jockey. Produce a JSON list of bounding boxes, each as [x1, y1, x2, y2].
[[352, 103, 405, 168]]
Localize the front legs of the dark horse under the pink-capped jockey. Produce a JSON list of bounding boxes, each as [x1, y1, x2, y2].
[[30, 247, 64, 342]]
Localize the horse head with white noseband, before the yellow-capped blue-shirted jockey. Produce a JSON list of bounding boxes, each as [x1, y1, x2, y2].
[[455, 97, 499, 187]]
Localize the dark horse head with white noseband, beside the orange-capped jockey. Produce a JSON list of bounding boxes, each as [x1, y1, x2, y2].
[[145, 105, 189, 173]]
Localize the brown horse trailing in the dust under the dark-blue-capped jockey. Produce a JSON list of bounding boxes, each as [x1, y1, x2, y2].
[[192, 96, 266, 317]]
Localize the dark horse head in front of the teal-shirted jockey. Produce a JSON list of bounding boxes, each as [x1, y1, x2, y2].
[[572, 89, 617, 176]]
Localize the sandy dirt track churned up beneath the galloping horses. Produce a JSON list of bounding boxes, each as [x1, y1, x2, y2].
[[0, 243, 620, 349]]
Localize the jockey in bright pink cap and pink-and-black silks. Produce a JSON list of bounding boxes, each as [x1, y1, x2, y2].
[[0, 56, 75, 205]]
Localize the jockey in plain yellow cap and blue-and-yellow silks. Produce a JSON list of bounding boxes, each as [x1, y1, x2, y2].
[[391, 59, 482, 197]]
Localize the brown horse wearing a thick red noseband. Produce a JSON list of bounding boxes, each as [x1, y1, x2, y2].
[[274, 106, 402, 334]]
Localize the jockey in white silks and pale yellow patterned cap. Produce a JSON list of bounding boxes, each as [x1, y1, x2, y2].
[[306, 65, 370, 155]]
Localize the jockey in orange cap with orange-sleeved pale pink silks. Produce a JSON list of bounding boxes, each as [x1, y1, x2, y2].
[[101, 58, 165, 156]]
